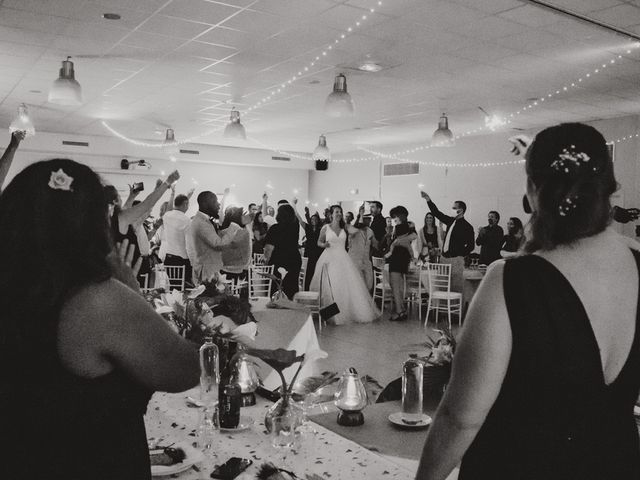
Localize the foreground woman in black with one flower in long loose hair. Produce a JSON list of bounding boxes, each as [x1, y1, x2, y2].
[[0, 159, 199, 480]]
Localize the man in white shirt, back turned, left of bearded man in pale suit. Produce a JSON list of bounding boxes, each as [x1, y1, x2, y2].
[[162, 195, 192, 283]]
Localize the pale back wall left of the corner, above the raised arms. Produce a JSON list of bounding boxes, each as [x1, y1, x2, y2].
[[7, 132, 313, 214]]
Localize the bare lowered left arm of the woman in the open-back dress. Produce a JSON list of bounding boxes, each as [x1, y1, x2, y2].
[[416, 262, 512, 480]]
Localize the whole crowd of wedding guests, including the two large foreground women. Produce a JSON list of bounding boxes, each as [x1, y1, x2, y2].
[[0, 124, 640, 480]]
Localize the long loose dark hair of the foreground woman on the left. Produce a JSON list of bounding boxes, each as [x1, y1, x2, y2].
[[0, 159, 112, 351]]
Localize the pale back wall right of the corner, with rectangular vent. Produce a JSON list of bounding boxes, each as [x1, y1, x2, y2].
[[309, 116, 640, 246]]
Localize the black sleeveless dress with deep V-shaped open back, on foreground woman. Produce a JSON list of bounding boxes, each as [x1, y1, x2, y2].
[[459, 252, 640, 480]]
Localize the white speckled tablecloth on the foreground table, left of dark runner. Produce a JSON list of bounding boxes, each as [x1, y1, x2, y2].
[[145, 388, 416, 480]]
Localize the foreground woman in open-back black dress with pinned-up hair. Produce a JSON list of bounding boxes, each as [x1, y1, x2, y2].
[[417, 124, 640, 480]]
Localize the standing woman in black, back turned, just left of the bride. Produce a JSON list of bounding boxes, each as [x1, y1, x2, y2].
[[264, 204, 302, 300]]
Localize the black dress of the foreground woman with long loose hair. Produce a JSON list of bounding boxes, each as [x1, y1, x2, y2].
[[0, 326, 152, 480]]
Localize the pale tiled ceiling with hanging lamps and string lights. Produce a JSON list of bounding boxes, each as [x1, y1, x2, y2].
[[0, 0, 640, 152]]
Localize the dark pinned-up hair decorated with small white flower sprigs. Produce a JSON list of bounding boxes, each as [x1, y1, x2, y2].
[[525, 123, 617, 252]]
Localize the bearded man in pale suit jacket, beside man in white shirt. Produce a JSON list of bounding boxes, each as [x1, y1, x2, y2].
[[186, 191, 239, 285]]
